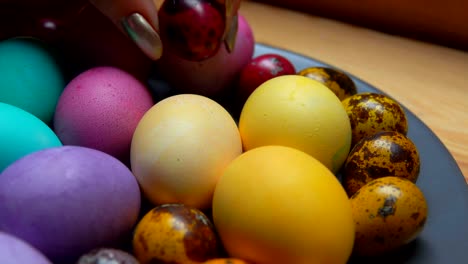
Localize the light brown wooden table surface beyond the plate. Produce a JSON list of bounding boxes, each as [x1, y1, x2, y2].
[[239, 1, 468, 181]]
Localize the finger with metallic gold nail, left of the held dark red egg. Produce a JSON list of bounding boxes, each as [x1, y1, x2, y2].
[[90, 0, 162, 60]]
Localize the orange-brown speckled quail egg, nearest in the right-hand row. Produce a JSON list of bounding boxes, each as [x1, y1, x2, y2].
[[350, 177, 428, 256]]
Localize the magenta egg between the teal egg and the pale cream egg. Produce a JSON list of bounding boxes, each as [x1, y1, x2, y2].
[[54, 67, 153, 162]]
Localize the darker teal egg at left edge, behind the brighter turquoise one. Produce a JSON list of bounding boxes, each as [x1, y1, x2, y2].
[[0, 37, 66, 124]]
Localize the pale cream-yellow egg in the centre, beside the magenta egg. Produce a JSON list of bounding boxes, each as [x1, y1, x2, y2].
[[130, 94, 242, 209]]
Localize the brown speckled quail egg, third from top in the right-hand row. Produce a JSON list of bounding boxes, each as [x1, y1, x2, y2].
[[343, 131, 420, 196]]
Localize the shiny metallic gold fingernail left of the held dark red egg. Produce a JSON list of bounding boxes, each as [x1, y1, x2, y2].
[[121, 13, 163, 60]]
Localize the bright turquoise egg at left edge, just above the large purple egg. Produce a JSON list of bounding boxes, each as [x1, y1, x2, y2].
[[0, 102, 62, 173]]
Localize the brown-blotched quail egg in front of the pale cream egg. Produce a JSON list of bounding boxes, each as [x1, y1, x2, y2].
[[133, 204, 220, 264]]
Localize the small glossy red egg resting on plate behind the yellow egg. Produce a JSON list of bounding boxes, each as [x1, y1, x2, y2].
[[238, 54, 296, 104]]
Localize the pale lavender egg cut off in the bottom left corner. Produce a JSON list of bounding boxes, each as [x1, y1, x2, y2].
[[0, 232, 52, 264]]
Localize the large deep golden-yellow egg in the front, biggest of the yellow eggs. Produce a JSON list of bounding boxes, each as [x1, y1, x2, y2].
[[212, 146, 355, 264]]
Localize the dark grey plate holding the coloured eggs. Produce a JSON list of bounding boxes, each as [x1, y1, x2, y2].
[[255, 44, 468, 264]]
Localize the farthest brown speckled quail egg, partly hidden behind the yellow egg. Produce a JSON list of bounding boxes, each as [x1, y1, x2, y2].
[[297, 67, 357, 100]]
